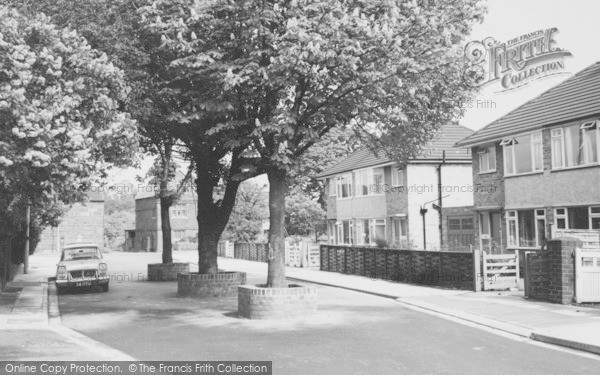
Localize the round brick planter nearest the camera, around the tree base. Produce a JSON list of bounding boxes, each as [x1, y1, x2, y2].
[[238, 284, 318, 319]]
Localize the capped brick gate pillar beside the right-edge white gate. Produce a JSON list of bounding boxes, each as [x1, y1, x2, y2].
[[547, 237, 582, 305]]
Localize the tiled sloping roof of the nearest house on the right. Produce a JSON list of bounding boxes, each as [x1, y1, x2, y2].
[[457, 61, 600, 147]]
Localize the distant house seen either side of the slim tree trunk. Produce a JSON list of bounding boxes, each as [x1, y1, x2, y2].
[[125, 189, 198, 252]]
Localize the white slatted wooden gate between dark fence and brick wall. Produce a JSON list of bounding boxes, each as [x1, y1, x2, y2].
[[481, 252, 519, 290]]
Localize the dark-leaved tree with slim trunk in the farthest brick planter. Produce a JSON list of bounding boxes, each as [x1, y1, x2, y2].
[[13, 0, 195, 263]]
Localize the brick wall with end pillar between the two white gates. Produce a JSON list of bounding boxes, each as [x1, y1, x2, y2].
[[524, 237, 582, 304]]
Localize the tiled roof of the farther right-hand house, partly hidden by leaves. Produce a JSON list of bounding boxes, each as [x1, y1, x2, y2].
[[317, 123, 473, 178]]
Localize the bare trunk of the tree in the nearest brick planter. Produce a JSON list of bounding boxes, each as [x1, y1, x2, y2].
[[267, 170, 288, 288]]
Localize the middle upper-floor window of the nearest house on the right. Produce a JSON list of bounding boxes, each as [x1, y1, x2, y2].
[[500, 132, 544, 175]]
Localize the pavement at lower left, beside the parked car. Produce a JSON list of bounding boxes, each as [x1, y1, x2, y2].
[[0, 254, 134, 361]]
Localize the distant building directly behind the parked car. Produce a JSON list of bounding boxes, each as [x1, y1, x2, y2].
[[37, 192, 104, 252]]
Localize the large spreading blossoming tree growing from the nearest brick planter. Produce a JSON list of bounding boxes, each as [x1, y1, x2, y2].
[[148, 0, 485, 287]]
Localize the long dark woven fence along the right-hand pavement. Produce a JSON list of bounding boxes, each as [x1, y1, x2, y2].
[[320, 245, 477, 290]]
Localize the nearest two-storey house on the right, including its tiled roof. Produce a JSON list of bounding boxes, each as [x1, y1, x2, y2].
[[458, 62, 600, 252]]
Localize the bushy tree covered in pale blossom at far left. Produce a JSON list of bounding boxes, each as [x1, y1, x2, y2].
[[0, 6, 137, 258]]
